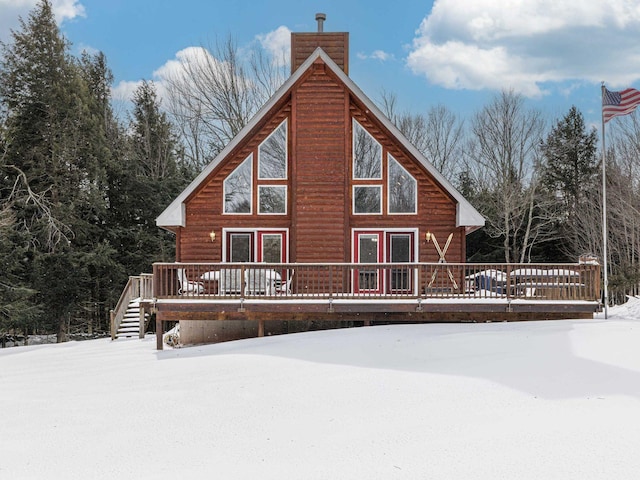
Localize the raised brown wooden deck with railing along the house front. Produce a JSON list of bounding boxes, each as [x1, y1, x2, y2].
[[143, 263, 601, 349]]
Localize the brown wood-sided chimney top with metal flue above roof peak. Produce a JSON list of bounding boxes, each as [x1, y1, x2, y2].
[[291, 13, 349, 75]]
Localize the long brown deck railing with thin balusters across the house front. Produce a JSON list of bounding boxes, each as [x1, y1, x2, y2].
[[153, 263, 601, 301]]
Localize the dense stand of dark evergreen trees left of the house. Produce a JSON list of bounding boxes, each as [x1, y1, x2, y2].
[[0, 1, 194, 341]]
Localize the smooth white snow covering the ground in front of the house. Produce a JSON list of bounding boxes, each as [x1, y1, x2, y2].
[[0, 299, 640, 480]]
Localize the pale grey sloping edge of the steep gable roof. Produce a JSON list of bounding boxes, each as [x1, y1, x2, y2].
[[156, 47, 484, 233]]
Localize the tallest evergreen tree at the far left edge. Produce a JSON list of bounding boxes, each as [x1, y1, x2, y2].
[[0, 0, 114, 340]]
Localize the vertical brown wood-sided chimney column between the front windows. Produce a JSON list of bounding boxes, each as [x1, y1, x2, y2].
[[292, 64, 348, 262]]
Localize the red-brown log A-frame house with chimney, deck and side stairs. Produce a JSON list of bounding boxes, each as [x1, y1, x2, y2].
[[112, 14, 600, 348]]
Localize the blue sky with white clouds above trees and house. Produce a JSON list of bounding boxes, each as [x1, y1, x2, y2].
[[0, 0, 640, 127]]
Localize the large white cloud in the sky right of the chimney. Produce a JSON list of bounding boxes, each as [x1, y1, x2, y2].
[[407, 0, 640, 97]]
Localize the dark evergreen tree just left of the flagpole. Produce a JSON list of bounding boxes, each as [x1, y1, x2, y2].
[[542, 106, 598, 261]]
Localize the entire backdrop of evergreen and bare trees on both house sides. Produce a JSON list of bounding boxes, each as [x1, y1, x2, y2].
[[0, 0, 640, 340]]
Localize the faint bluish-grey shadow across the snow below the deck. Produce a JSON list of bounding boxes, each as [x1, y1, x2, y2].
[[158, 320, 640, 399]]
